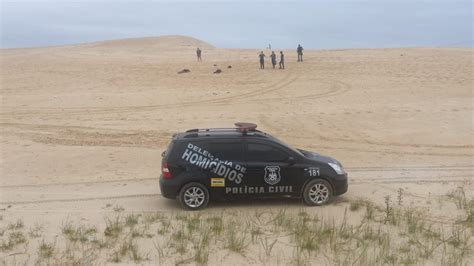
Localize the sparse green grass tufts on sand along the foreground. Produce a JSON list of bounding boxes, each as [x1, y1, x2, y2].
[[0, 195, 474, 265]]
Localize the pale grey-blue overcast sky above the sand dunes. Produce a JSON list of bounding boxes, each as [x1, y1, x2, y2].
[[0, 0, 473, 49]]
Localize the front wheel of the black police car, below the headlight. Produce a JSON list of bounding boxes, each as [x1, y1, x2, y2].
[[303, 179, 332, 206]]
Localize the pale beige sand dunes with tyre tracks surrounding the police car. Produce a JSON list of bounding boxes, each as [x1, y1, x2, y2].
[[0, 36, 474, 263]]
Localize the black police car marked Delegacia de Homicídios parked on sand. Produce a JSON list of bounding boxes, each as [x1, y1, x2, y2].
[[160, 123, 347, 210]]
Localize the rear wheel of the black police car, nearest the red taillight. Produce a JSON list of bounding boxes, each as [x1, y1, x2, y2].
[[178, 183, 209, 210]]
